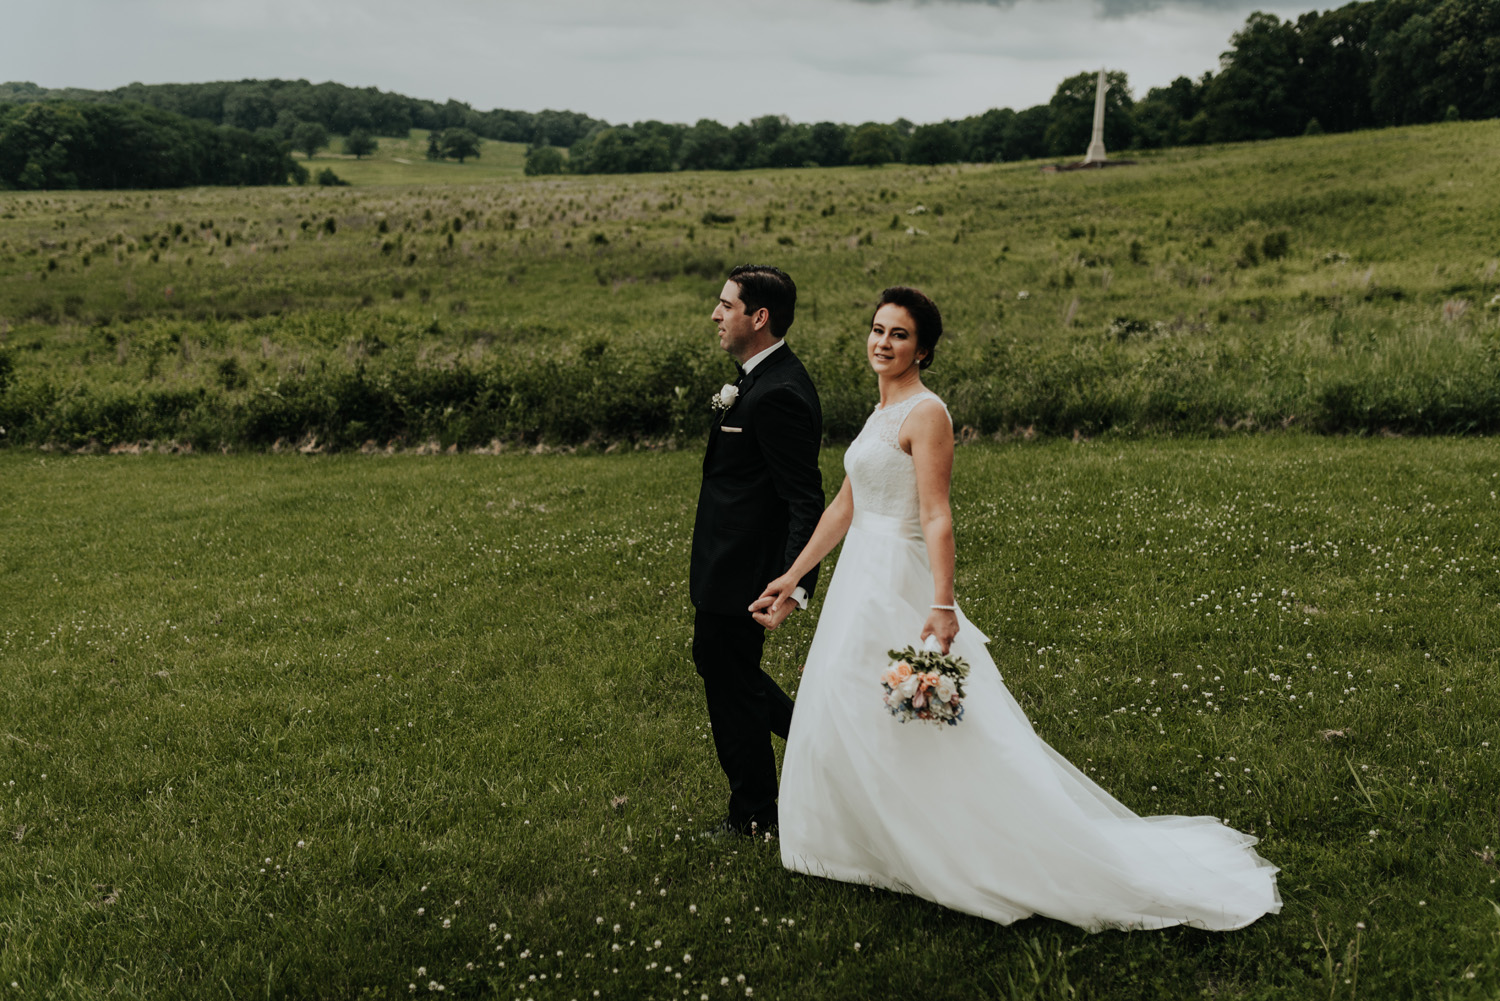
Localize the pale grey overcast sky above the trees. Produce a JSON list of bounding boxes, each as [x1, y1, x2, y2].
[[0, 0, 1326, 123]]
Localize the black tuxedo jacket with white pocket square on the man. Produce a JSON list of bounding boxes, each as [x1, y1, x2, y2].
[[689, 347, 824, 615]]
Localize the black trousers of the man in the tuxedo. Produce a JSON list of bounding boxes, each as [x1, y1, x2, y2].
[[693, 611, 792, 830]]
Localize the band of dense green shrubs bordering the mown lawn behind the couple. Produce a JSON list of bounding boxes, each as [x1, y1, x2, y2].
[[0, 321, 1500, 449]]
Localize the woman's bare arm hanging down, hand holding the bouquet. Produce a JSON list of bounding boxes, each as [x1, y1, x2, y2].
[[902, 402, 959, 653]]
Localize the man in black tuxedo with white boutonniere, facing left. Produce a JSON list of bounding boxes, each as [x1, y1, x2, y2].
[[690, 266, 824, 834]]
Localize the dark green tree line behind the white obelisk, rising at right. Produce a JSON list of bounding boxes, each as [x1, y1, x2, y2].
[[543, 0, 1500, 173]]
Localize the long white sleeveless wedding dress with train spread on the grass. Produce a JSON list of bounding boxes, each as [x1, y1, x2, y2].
[[780, 393, 1281, 930]]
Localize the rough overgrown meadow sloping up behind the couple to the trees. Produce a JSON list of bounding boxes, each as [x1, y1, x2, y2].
[[0, 122, 1500, 449]]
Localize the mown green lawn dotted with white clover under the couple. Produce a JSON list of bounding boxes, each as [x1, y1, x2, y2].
[[0, 434, 1500, 1001]]
